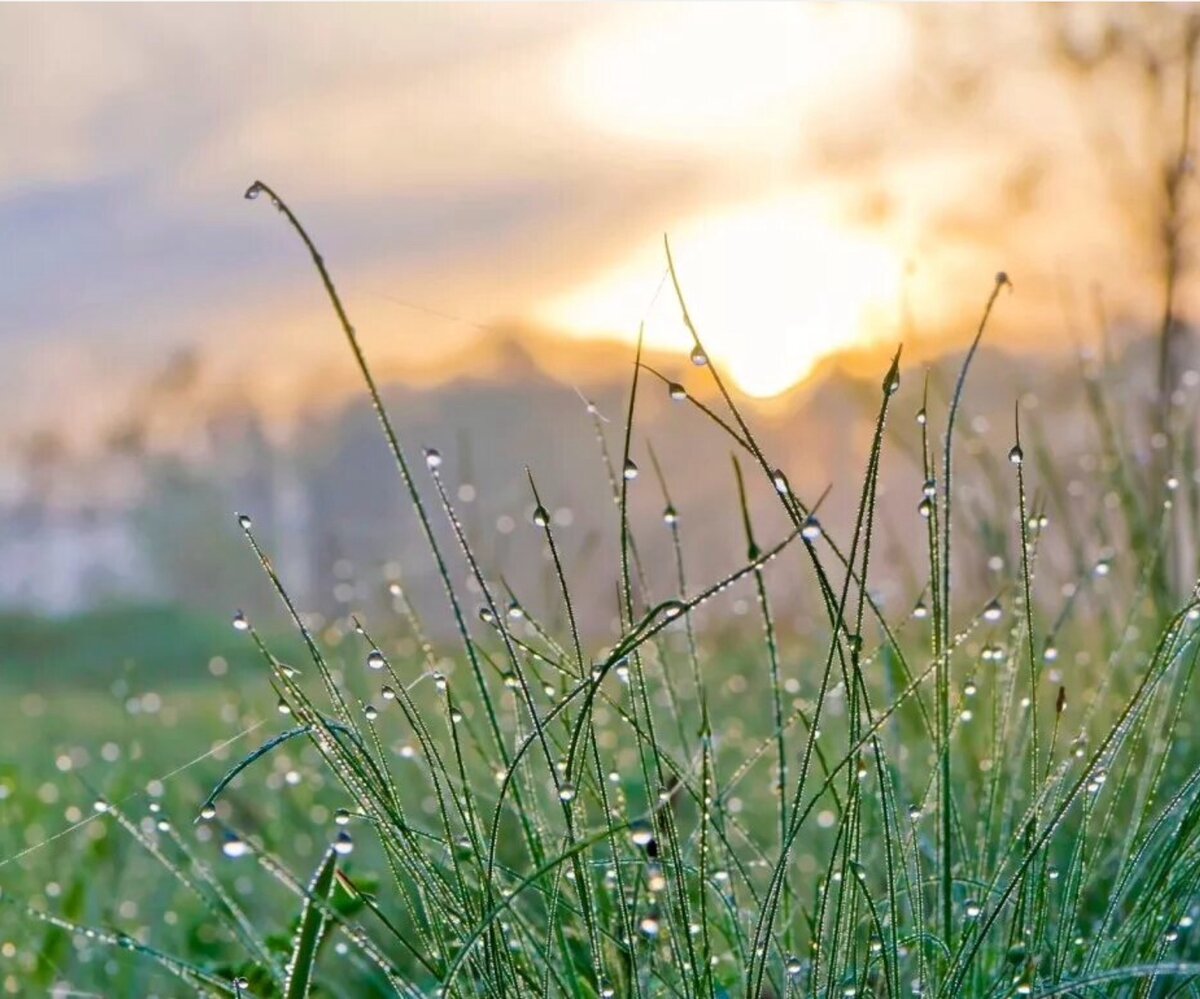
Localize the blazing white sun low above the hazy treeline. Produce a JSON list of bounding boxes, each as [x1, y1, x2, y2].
[[538, 196, 904, 397]]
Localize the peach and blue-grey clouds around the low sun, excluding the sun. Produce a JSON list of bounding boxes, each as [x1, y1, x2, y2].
[[0, 5, 1195, 451]]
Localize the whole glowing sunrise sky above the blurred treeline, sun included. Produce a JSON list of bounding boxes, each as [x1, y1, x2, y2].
[[0, 4, 1195, 445]]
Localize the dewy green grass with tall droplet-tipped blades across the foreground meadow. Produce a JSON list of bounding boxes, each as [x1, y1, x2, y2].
[[0, 183, 1200, 999]]
